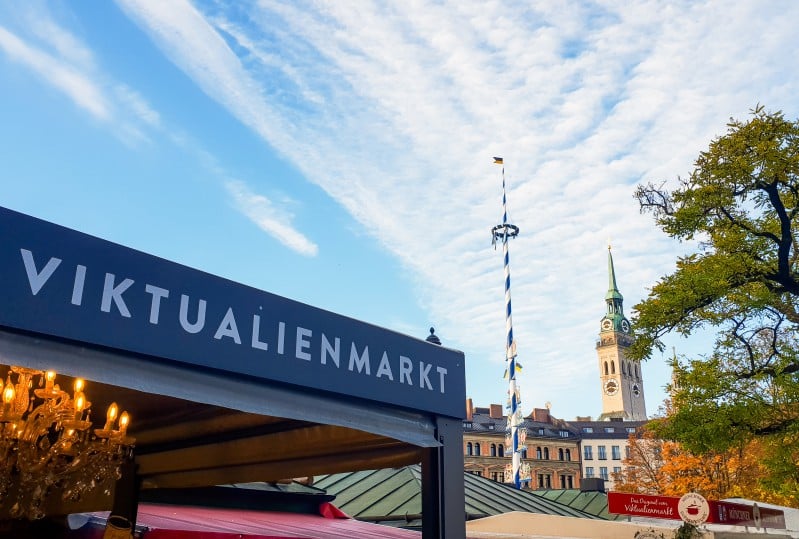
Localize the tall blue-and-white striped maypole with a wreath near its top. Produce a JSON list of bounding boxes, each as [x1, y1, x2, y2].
[[491, 157, 524, 488]]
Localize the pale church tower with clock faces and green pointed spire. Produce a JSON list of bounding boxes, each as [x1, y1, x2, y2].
[[596, 245, 646, 421]]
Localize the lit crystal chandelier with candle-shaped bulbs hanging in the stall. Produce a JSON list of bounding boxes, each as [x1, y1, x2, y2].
[[0, 366, 135, 520]]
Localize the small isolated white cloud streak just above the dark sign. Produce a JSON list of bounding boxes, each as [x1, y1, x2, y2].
[[225, 180, 319, 256]]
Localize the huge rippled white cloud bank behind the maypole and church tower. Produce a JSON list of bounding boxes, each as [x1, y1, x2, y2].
[[119, 0, 799, 414]]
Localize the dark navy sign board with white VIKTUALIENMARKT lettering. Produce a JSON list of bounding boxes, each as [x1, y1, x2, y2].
[[0, 208, 466, 418]]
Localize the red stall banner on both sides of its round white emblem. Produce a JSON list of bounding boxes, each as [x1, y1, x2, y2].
[[608, 492, 785, 529]]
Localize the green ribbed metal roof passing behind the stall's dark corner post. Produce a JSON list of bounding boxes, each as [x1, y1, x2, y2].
[[314, 465, 607, 521]]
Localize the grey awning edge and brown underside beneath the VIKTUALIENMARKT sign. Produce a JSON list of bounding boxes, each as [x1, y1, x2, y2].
[[0, 330, 440, 514]]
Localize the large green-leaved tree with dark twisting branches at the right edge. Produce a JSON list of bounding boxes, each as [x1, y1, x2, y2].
[[628, 106, 799, 500]]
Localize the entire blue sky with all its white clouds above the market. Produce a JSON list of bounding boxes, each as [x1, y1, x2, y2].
[[0, 0, 799, 419]]
